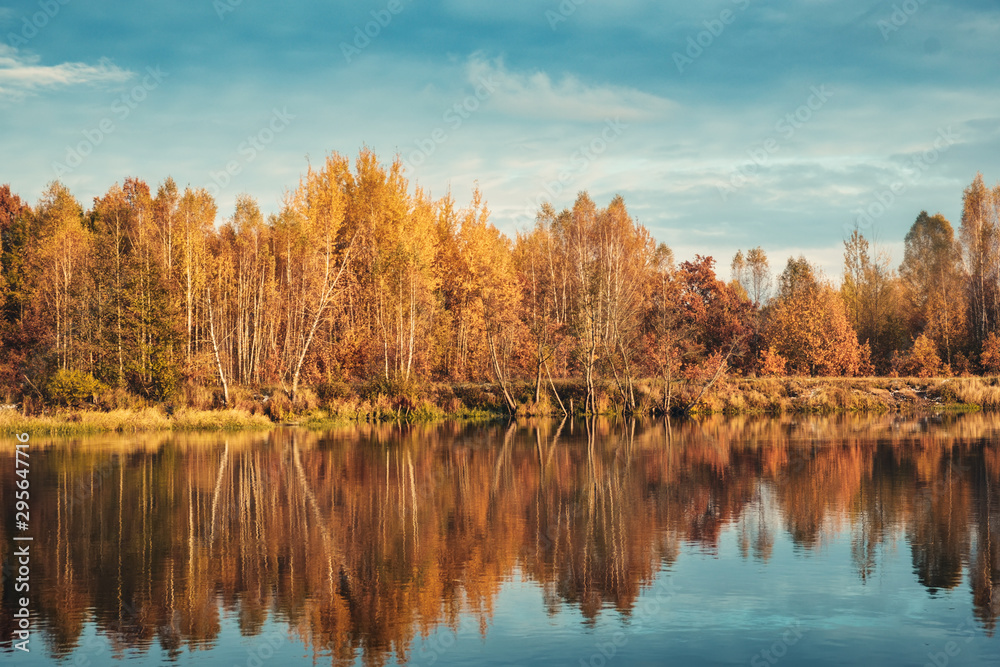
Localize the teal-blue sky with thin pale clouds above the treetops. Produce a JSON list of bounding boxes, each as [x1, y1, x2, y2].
[[0, 0, 1000, 281]]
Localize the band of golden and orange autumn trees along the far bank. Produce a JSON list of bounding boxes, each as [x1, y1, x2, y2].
[[0, 149, 1000, 414]]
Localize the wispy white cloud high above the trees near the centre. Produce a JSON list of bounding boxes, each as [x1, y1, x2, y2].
[[466, 54, 676, 121]]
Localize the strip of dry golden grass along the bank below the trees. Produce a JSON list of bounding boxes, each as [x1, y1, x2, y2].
[[7, 377, 1000, 435]]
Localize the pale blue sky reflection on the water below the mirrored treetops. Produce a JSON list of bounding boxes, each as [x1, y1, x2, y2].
[[19, 526, 988, 666]]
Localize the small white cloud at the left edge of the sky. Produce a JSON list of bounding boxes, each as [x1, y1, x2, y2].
[[0, 44, 133, 99]]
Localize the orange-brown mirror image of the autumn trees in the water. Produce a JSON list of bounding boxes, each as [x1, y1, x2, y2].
[[0, 414, 1000, 664]]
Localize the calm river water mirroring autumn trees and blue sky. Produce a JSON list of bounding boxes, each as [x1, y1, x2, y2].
[[0, 414, 1000, 667]]
